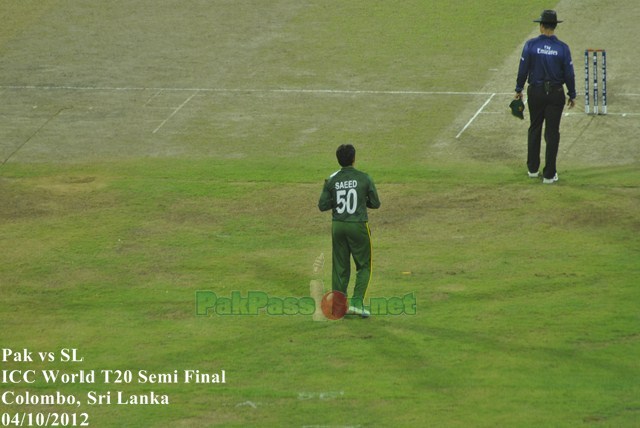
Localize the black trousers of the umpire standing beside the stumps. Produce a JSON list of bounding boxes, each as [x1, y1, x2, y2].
[[527, 85, 565, 178]]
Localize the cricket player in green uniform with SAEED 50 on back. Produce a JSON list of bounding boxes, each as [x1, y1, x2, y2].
[[318, 144, 380, 318]]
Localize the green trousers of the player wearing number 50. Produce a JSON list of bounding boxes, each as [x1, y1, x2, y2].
[[331, 221, 372, 308]]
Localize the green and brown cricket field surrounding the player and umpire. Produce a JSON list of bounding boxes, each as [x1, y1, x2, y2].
[[0, 0, 640, 428]]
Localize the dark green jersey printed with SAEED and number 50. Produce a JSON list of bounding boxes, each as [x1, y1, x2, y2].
[[318, 166, 380, 223]]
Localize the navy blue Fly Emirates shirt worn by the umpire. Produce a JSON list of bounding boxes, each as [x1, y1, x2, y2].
[[516, 34, 576, 99]]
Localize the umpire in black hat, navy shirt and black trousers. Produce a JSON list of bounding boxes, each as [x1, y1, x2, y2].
[[515, 10, 576, 184]]
